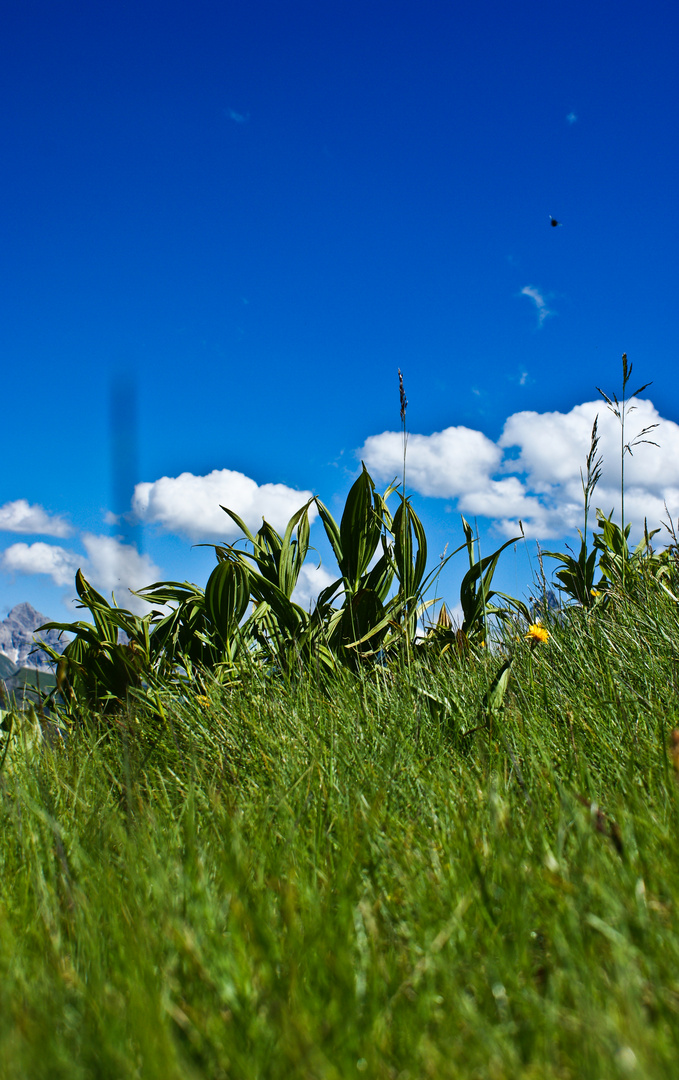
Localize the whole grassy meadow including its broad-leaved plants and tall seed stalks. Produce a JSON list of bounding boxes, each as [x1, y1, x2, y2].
[[0, 365, 679, 1080]]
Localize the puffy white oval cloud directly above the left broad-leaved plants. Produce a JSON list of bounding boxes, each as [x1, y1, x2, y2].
[[132, 469, 316, 541]]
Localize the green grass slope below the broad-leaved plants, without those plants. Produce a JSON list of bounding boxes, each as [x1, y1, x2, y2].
[[0, 591, 679, 1080]]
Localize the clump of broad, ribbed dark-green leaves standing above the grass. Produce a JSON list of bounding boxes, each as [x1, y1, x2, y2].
[[34, 465, 528, 715]]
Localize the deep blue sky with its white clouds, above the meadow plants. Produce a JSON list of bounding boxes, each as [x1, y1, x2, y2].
[[0, 0, 679, 618]]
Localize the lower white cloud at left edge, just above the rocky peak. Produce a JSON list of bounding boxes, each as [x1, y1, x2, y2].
[[2, 532, 161, 613]]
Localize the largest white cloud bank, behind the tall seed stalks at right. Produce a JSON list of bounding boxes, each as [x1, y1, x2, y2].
[[358, 400, 679, 538]]
